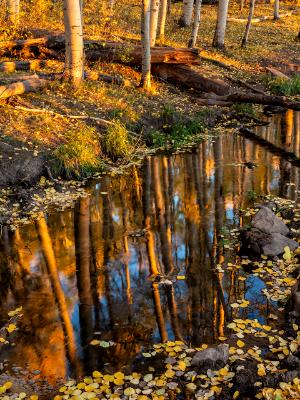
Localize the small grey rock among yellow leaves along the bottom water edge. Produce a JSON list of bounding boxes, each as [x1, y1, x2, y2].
[[192, 344, 229, 371]]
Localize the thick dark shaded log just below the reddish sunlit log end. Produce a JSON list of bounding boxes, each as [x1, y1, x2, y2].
[[152, 64, 230, 95]]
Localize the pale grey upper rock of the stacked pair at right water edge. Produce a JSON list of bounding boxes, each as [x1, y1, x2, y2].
[[251, 207, 289, 236]]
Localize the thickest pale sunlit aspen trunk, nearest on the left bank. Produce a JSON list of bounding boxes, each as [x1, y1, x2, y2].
[[64, 0, 83, 86]]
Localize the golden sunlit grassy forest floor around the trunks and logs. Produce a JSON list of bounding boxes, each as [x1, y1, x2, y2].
[[0, 0, 300, 222]]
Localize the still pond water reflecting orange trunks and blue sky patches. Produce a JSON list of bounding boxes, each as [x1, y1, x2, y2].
[[0, 111, 300, 383]]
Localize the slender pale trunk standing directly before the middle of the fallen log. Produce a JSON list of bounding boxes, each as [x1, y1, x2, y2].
[[140, 0, 151, 91]]
